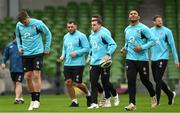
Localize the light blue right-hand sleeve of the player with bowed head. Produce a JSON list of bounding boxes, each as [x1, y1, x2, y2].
[[39, 21, 52, 51]]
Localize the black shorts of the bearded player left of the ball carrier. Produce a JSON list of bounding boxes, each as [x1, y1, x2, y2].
[[64, 66, 84, 83]]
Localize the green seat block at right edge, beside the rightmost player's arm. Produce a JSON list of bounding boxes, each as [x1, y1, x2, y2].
[[165, 0, 180, 89]]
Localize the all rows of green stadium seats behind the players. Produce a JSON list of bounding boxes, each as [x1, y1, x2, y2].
[[0, 0, 180, 85]]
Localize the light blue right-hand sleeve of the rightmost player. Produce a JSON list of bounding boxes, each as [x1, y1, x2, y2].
[[167, 30, 179, 62]]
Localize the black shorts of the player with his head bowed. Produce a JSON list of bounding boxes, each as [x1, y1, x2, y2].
[[22, 54, 43, 72]]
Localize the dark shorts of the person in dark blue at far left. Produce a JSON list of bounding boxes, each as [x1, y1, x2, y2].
[[11, 72, 24, 82]]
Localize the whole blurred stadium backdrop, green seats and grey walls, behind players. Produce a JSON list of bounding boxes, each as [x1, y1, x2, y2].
[[0, 0, 180, 95]]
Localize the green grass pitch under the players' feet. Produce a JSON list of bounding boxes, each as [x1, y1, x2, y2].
[[0, 95, 180, 113]]
